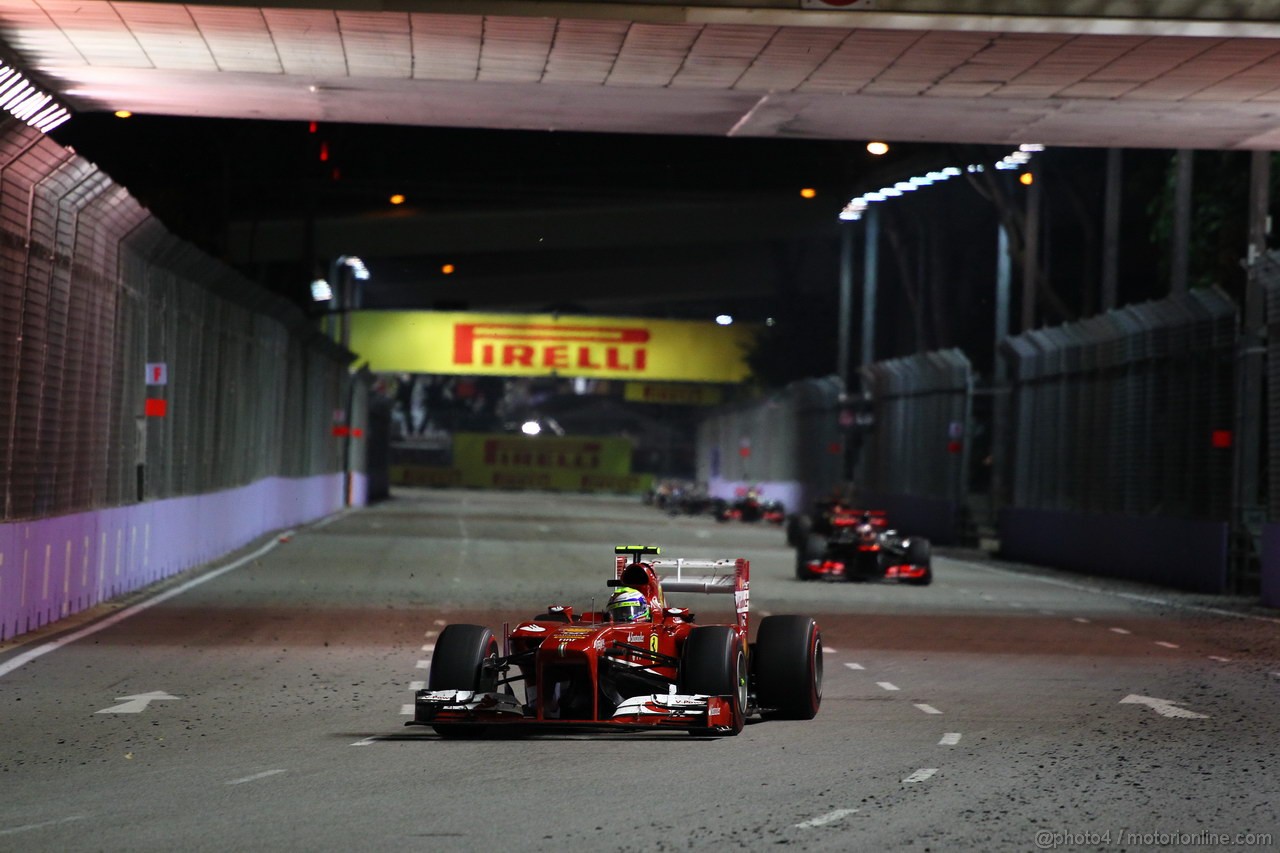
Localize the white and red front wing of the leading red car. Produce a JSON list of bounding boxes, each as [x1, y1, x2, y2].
[[404, 690, 733, 733]]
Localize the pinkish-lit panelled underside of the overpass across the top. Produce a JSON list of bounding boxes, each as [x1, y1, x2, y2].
[[0, 0, 1280, 149]]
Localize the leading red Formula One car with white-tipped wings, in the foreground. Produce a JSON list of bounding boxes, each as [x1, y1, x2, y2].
[[406, 546, 822, 736]]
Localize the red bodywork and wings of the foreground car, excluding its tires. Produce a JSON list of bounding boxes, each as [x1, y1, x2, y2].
[[407, 555, 750, 733]]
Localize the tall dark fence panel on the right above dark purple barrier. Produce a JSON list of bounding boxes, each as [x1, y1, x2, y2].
[[997, 289, 1238, 521]]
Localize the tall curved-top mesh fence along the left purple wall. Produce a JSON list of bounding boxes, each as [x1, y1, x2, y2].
[[0, 122, 349, 521]]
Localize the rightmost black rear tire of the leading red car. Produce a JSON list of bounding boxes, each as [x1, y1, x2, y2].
[[754, 616, 822, 720]]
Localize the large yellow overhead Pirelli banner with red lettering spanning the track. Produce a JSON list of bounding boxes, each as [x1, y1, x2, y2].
[[348, 311, 755, 383]]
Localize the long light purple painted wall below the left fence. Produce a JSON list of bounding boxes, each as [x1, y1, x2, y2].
[[0, 474, 350, 640]]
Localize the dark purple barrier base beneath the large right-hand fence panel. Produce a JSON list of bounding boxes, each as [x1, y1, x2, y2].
[[1000, 507, 1228, 593]]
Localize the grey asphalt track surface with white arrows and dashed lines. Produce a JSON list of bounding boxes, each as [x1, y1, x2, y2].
[[0, 491, 1280, 852]]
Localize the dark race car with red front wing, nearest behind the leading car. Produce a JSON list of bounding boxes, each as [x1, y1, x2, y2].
[[796, 506, 933, 587]]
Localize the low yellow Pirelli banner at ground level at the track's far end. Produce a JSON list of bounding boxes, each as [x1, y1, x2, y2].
[[392, 433, 653, 492]]
